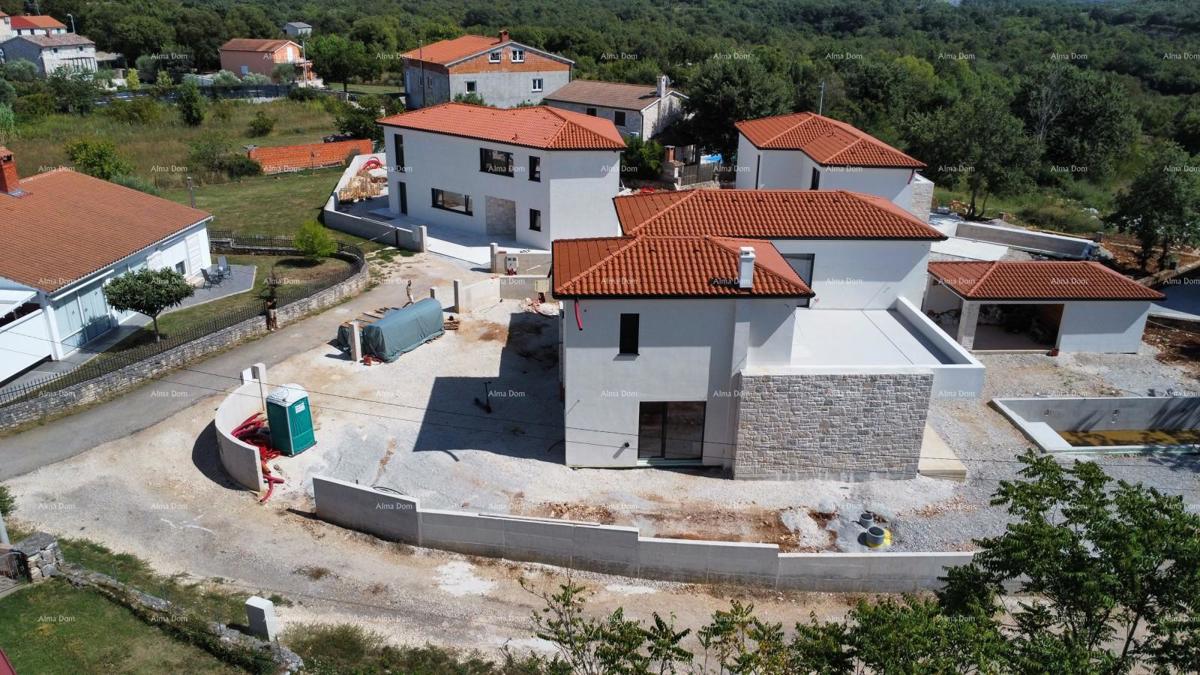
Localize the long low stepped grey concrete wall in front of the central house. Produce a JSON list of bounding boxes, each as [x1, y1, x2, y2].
[[312, 476, 974, 592]]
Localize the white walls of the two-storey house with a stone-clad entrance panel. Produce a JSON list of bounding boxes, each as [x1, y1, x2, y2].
[[384, 127, 620, 249]]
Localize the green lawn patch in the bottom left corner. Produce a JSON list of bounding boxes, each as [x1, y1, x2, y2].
[[0, 579, 241, 675]]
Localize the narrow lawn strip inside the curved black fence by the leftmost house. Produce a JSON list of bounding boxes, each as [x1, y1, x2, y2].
[[95, 256, 350, 363]]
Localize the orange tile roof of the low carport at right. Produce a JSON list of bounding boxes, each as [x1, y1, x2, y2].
[[929, 261, 1165, 300]]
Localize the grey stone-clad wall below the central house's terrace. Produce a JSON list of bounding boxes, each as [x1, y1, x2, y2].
[[733, 372, 934, 480]]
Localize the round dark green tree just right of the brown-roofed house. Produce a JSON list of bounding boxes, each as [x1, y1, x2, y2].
[[684, 54, 792, 163]]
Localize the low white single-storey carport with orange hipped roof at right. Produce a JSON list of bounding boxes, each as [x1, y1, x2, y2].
[[923, 261, 1164, 353]]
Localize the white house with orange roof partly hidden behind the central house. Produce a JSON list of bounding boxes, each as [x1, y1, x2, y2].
[[736, 113, 934, 221]]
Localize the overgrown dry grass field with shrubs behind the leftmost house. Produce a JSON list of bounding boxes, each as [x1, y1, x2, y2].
[[8, 98, 336, 189]]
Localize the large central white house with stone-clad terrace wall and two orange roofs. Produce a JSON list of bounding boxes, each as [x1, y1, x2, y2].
[[552, 190, 983, 479]]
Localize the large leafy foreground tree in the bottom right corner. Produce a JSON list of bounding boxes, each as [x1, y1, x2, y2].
[[940, 450, 1200, 673]]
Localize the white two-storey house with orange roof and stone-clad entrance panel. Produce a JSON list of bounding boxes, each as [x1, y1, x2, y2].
[[379, 103, 625, 250]]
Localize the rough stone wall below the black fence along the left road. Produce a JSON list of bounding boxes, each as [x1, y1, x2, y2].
[[0, 252, 371, 431]]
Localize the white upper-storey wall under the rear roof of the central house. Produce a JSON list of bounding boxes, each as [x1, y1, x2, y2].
[[772, 239, 930, 310]]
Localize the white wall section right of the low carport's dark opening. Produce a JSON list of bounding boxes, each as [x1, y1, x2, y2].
[[1058, 300, 1150, 353]]
